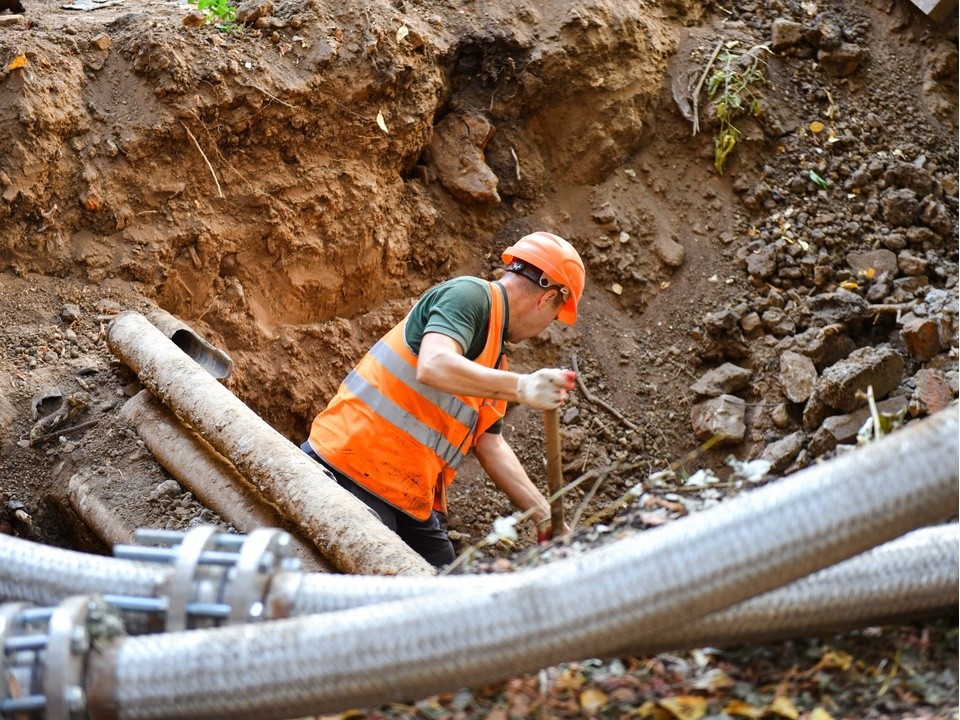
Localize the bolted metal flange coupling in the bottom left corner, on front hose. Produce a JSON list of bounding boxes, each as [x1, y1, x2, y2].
[[0, 595, 109, 720]]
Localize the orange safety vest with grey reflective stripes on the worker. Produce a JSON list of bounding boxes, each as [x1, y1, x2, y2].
[[310, 281, 507, 520]]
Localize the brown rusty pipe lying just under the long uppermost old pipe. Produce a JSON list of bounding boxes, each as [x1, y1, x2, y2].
[[121, 390, 333, 572]]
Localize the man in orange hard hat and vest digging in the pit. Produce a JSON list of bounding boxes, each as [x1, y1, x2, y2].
[[301, 232, 584, 567]]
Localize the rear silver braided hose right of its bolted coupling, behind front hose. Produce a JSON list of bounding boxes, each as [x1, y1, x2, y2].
[[270, 523, 960, 628]]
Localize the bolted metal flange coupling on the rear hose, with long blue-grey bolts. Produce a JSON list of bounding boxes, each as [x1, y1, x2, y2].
[[105, 526, 299, 632]]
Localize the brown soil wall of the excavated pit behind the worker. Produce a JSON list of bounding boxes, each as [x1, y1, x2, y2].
[[0, 0, 957, 716]]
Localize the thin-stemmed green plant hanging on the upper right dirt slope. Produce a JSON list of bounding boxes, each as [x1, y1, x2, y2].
[[707, 45, 769, 174]]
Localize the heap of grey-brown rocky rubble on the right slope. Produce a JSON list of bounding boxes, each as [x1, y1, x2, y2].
[[690, 3, 958, 472]]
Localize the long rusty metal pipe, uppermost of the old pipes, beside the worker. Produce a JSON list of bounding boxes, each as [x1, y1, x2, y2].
[[107, 311, 435, 575]]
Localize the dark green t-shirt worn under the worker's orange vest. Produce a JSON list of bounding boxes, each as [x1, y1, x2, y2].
[[404, 277, 509, 433]]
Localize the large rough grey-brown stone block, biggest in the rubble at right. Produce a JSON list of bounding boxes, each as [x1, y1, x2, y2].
[[819, 345, 904, 412]]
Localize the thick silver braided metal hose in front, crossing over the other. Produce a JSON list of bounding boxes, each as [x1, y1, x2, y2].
[[87, 407, 958, 720]]
